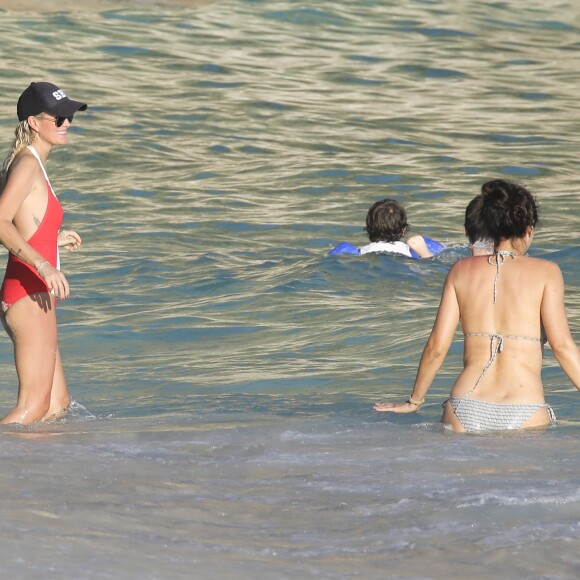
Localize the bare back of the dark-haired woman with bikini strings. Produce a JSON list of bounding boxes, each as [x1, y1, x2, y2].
[[449, 256, 557, 403]]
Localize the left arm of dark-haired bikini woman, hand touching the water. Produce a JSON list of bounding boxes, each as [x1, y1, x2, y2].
[[374, 267, 459, 413]]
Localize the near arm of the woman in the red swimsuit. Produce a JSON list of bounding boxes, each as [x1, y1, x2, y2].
[[0, 156, 70, 299]]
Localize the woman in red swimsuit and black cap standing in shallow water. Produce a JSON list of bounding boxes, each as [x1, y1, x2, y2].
[[0, 82, 87, 425]]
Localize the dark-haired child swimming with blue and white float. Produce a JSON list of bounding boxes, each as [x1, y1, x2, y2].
[[329, 199, 445, 259]]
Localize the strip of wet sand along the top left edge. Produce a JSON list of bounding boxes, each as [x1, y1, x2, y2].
[[0, 0, 219, 12]]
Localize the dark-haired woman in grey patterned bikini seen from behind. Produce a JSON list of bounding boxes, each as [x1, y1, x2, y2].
[[374, 179, 580, 432]]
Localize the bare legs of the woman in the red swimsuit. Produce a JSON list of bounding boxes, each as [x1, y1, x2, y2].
[[0, 294, 68, 425]]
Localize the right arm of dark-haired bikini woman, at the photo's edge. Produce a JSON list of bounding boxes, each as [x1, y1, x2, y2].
[[541, 263, 580, 390]]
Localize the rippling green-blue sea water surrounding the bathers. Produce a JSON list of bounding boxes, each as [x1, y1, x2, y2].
[[0, 0, 580, 579]]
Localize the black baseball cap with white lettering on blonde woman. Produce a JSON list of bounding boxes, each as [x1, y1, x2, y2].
[[16, 82, 87, 121]]
